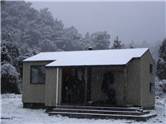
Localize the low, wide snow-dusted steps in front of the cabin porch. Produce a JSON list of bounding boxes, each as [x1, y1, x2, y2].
[[46, 105, 156, 121]]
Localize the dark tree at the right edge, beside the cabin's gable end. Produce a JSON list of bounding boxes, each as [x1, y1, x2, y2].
[[157, 39, 166, 79]]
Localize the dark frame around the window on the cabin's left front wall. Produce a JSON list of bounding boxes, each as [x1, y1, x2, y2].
[[30, 65, 46, 85]]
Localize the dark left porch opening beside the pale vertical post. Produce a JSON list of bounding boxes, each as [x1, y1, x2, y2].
[[62, 67, 85, 105]]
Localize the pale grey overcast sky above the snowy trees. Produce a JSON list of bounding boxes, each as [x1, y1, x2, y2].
[[32, 2, 166, 42]]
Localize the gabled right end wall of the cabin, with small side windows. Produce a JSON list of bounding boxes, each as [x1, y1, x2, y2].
[[140, 51, 155, 108]]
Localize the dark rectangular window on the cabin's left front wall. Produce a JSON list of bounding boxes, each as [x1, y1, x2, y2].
[[31, 65, 45, 84]]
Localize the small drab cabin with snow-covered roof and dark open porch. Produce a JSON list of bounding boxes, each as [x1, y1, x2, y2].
[[22, 48, 155, 119]]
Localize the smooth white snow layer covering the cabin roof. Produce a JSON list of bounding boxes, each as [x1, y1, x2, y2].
[[24, 48, 148, 67]]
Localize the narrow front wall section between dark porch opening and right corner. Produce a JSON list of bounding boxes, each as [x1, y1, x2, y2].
[[126, 59, 141, 106]]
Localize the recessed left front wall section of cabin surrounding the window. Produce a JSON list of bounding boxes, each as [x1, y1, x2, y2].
[[22, 62, 49, 103]]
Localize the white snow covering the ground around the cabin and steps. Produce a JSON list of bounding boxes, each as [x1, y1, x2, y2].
[[1, 94, 166, 124]]
